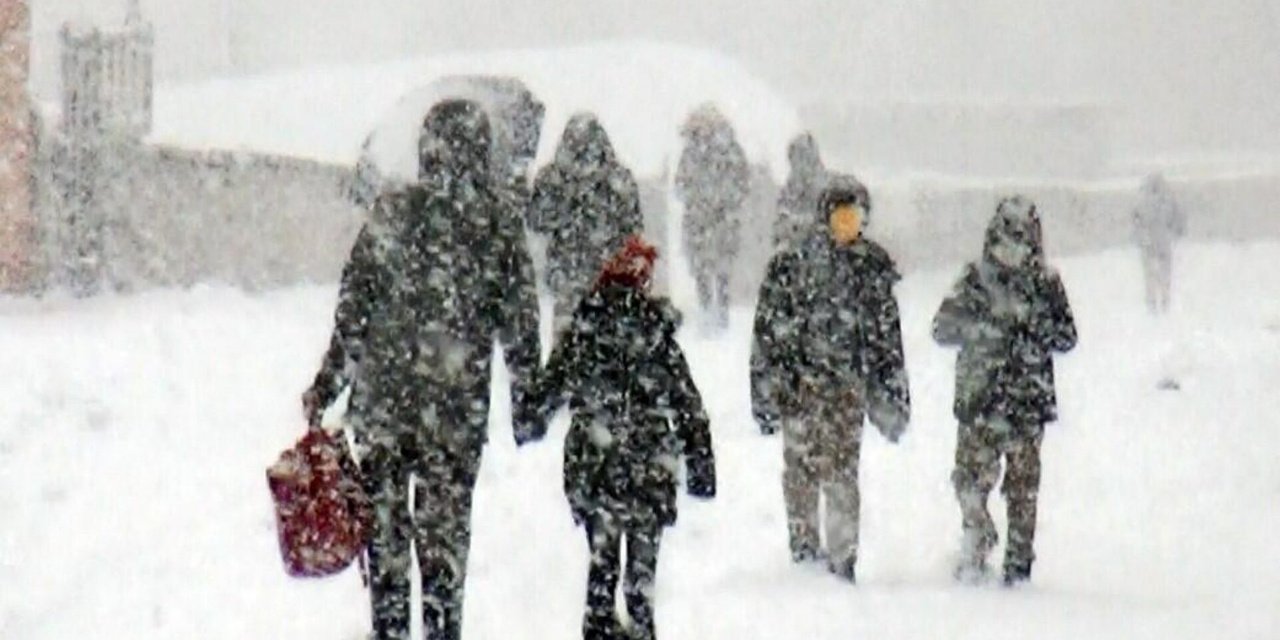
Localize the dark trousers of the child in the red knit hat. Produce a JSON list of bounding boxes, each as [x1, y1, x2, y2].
[[582, 513, 662, 640]]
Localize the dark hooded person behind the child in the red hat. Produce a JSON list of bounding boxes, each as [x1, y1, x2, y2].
[[529, 114, 644, 333]]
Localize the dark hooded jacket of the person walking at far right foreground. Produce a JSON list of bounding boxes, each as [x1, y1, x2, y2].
[[933, 201, 1076, 429]]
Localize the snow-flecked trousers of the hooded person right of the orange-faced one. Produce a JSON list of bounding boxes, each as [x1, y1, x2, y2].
[[951, 420, 1044, 580]]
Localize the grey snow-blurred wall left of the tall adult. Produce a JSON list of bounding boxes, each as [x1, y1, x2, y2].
[[37, 140, 361, 291]]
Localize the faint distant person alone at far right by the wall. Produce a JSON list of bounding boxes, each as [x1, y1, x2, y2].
[[1133, 173, 1187, 314]]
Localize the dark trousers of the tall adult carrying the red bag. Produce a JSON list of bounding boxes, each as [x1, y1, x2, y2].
[[365, 452, 479, 640]]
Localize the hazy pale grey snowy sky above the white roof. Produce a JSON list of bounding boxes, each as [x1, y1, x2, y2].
[[33, 0, 1280, 156]]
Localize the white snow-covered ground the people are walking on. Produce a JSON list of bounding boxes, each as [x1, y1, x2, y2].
[[0, 243, 1280, 640]]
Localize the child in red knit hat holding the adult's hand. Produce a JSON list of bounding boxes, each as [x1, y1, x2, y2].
[[522, 237, 716, 640]]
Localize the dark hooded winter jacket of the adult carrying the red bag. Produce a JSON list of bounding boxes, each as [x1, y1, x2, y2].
[[312, 102, 540, 456]]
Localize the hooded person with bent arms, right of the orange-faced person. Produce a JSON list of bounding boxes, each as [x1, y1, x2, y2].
[[933, 196, 1075, 584]]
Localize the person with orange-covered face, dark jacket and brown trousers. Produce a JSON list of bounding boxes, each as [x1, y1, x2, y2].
[[751, 175, 910, 581]]
